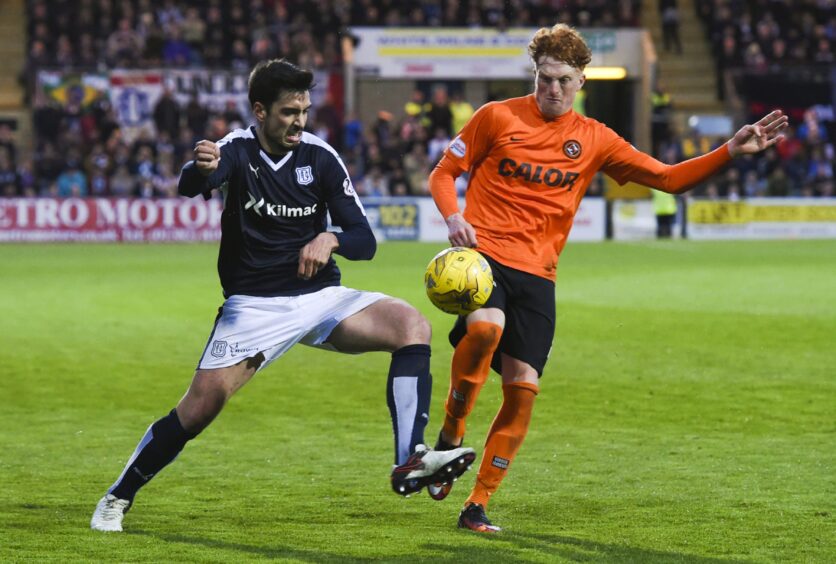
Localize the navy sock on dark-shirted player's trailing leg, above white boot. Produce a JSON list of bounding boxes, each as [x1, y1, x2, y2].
[[107, 409, 197, 501]]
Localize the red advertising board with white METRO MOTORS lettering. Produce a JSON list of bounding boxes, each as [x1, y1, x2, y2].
[[0, 198, 222, 242]]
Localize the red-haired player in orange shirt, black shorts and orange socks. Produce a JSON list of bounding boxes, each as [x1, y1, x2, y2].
[[430, 24, 787, 533]]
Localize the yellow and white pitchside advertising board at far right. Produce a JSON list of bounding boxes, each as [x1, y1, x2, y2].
[[688, 198, 836, 239]]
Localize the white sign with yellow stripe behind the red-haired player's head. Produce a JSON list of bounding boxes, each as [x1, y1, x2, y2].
[[351, 27, 642, 80]]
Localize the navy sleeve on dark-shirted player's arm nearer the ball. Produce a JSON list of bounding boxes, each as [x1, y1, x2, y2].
[[320, 153, 377, 260]]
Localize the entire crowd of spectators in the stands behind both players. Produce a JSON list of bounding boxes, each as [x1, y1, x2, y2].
[[0, 0, 834, 198]]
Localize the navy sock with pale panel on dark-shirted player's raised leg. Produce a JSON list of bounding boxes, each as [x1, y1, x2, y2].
[[386, 345, 432, 465]]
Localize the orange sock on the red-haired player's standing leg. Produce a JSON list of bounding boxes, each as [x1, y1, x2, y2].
[[466, 382, 538, 506]]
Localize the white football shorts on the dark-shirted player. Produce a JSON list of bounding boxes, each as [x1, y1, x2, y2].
[[197, 286, 389, 370]]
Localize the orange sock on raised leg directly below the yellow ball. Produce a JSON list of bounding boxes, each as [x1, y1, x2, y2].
[[442, 321, 502, 443]]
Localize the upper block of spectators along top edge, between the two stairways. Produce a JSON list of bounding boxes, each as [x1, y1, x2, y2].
[[27, 0, 640, 69]]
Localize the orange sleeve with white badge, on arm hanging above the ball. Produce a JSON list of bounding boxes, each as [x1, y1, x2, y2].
[[429, 104, 494, 219]]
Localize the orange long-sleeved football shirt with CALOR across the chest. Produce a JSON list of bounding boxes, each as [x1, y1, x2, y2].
[[430, 94, 730, 280]]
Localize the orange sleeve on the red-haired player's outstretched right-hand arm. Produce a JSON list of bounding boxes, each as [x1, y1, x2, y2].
[[601, 128, 731, 194]]
